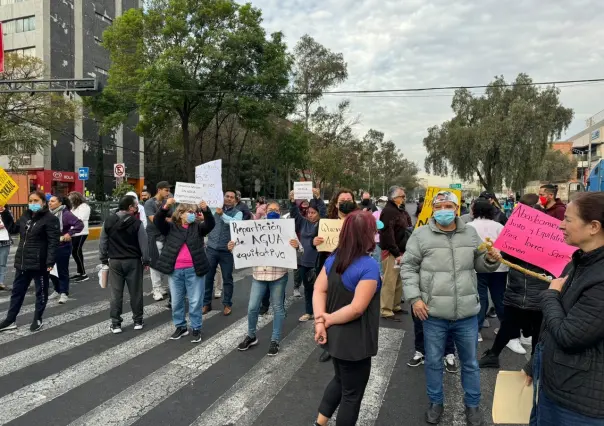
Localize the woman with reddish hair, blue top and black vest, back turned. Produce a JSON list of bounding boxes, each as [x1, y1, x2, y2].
[[313, 211, 382, 426]]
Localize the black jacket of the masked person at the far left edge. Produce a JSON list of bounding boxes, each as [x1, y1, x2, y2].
[[2, 207, 61, 271]]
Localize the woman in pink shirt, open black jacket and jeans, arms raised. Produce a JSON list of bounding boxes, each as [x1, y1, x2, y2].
[[153, 198, 214, 343]]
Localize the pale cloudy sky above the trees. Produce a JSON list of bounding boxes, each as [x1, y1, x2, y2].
[[251, 0, 604, 183]]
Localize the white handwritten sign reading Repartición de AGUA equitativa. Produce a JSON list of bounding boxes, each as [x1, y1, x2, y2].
[[230, 219, 298, 269]]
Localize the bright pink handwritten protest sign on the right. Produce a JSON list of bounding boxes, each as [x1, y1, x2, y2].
[[493, 204, 577, 277]]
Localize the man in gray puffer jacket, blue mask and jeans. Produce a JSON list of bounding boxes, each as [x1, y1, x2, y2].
[[401, 191, 500, 426]]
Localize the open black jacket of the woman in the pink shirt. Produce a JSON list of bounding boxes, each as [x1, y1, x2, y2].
[[153, 208, 215, 277]]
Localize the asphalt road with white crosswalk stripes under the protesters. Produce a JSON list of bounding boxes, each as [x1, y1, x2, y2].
[[0, 218, 525, 426]]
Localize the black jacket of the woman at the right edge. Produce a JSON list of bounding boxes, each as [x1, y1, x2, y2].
[[540, 247, 604, 419]]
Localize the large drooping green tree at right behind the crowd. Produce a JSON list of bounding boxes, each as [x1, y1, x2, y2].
[[424, 74, 573, 191]]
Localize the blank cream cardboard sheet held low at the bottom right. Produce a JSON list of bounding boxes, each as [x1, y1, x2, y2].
[[493, 371, 533, 425]]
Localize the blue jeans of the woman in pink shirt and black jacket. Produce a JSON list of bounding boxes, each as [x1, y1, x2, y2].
[[169, 268, 205, 330]]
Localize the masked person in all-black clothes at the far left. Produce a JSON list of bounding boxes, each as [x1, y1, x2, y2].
[[0, 191, 61, 332]]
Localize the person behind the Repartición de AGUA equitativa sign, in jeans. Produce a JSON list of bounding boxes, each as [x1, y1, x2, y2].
[[228, 202, 304, 356]]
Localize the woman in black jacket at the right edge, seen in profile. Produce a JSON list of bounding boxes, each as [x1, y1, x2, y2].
[[524, 192, 604, 426]]
